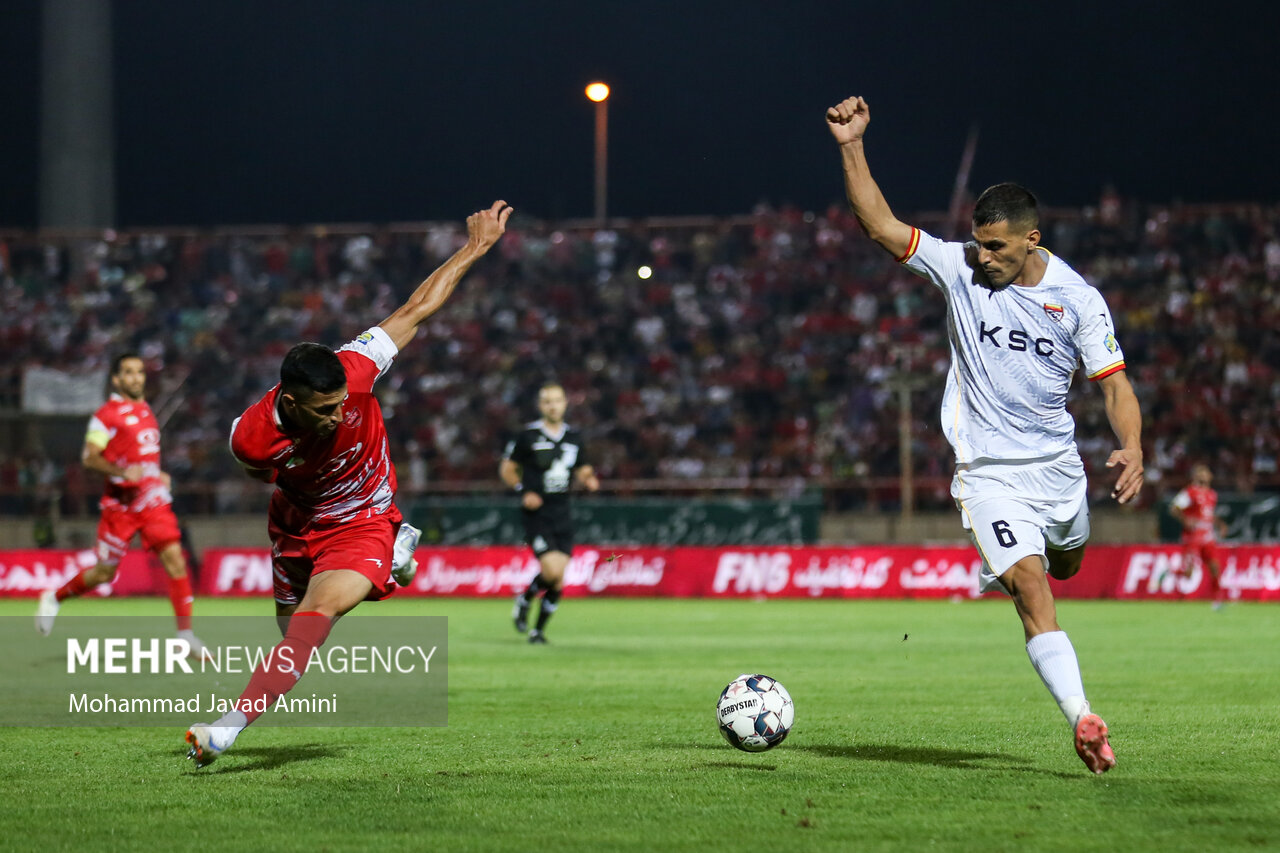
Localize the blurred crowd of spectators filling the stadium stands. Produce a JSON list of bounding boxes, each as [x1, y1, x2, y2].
[[0, 196, 1280, 510]]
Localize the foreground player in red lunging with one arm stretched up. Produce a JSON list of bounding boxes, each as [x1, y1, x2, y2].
[[186, 201, 511, 767]]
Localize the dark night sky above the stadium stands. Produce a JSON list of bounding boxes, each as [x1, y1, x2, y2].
[[0, 0, 1280, 227]]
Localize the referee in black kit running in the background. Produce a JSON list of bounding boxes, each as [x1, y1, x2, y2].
[[498, 383, 600, 643]]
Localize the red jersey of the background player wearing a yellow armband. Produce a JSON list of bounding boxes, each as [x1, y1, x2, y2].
[[84, 393, 173, 511]]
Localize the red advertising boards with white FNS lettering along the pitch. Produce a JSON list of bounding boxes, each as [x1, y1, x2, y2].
[[0, 546, 1280, 601]]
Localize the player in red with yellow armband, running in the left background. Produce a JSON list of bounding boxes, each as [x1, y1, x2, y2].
[[36, 352, 205, 654]]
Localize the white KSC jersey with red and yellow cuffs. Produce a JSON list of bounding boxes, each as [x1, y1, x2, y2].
[[899, 228, 1124, 464]]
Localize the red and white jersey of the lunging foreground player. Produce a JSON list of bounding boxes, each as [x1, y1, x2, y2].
[[230, 327, 401, 534]]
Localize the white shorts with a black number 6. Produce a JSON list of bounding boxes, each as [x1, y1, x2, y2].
[[951, 447, 1089, 592]]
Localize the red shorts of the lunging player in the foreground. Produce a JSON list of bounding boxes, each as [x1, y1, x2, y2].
[[266, 515, 399, 605]]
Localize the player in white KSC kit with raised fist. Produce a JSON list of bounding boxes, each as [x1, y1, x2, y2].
[[827, 91, 1143, 774]]
